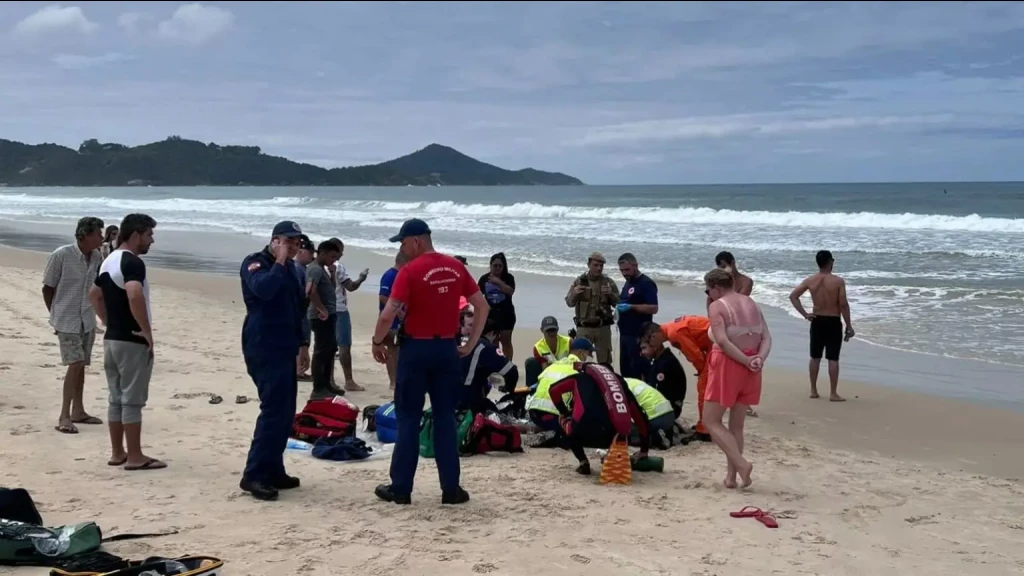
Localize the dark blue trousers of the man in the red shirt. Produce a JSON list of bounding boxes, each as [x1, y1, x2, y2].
[[389, 338, 461, 496]]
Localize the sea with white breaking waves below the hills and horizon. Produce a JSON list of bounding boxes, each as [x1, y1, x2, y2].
[[6, 182, 1024, 367]]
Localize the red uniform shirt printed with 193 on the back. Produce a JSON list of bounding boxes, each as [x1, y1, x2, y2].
[[391, 252, 480, 338]]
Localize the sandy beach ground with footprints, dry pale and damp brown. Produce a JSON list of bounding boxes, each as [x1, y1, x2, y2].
[[0, 243, 1024, 576]]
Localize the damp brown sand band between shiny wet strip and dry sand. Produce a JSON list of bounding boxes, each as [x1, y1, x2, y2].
[[0, 246, 1024, 479]]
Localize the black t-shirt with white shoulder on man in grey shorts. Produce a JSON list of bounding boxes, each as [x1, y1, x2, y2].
[[95, 250, 153, 344]]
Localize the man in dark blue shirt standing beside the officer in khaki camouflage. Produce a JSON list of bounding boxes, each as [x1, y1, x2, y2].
[[616, 252, 657, 378]]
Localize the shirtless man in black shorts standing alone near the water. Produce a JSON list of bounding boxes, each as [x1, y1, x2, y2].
[[790, 250, 854, 402]]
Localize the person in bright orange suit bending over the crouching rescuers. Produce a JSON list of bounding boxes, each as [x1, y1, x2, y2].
[[641, 316, 712, 440]]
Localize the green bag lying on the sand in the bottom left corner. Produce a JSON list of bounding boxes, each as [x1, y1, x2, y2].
[[0, 519, 103, 566]]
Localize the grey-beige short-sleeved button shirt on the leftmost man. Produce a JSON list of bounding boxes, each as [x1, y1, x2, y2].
[[43, 243, 101, 334]]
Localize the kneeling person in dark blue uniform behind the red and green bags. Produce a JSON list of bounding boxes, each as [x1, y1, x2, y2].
[[457, 318, 519, 414]]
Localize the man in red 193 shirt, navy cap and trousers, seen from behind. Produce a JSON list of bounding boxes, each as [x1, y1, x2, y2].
[[373, 218, 488, 504]]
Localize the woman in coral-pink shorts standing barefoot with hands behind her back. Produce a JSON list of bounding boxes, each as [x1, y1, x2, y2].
[[705, 269, 771, 488]]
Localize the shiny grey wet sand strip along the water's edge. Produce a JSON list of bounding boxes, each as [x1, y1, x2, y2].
[[6, 213, 1024, 413]]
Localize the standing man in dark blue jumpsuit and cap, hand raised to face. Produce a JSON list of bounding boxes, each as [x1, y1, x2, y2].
[[239, 220, 305, 500]]
